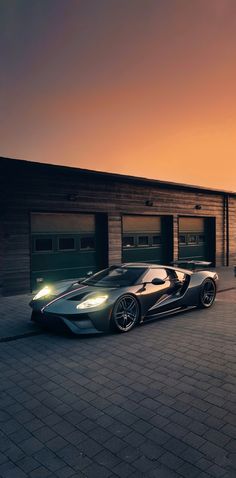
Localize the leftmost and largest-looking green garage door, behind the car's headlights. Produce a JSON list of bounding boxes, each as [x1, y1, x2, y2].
[[31, 213, 107, 290]]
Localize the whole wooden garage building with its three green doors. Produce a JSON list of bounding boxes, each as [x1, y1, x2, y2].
[[0, 158, 236, 295]]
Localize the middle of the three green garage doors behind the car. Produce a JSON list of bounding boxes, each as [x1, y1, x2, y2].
[[122, 216, 163, 264]]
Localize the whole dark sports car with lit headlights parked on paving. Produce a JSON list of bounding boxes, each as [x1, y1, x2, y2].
[[30, 263, 218, 334]]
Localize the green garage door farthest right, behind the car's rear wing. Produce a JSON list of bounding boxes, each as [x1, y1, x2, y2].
[[179, 217, 215, 263]]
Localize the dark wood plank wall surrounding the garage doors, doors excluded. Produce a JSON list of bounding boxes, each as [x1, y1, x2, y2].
[[0, 158, 236, 294]]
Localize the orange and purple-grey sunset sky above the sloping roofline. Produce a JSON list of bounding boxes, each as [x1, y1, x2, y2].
[[0, 0, 236, 191]]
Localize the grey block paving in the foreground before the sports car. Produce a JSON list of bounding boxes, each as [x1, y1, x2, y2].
[[0, 291, 236, 478]]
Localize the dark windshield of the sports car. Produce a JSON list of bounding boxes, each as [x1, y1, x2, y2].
[[83, 267, 146, 287]]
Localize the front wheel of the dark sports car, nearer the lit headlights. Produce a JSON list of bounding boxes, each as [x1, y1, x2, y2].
[[111, 294, 139, 332]]
